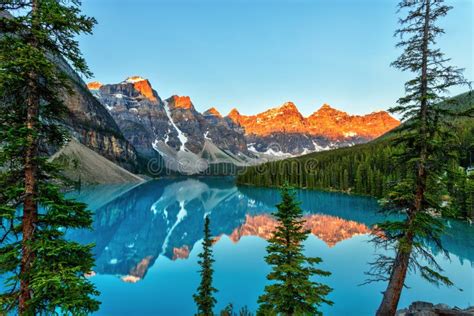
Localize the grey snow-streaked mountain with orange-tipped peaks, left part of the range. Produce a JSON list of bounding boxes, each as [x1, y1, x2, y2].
[[89, 76, 252, 173]]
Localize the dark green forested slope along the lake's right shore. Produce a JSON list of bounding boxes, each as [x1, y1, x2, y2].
[[237, 92, 474, 218]]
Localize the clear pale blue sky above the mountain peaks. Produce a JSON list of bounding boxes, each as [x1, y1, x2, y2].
[[80, 0, 474, 115]]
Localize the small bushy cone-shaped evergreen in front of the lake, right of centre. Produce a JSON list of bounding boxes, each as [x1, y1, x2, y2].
[[258, 185, 332, 315]]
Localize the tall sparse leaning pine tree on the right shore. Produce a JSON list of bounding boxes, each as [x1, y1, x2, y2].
[[369, 0, 464, 316]]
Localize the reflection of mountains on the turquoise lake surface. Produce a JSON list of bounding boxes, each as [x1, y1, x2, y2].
[[70, 178, 474, 283]]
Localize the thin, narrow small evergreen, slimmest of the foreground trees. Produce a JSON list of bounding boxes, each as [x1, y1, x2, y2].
[[193, 216, 217, 316]]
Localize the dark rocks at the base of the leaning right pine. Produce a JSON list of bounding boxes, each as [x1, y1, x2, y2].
[[396, 302, 474, 316]]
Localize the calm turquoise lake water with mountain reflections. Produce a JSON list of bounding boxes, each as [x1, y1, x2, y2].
[[71, 178, 474, 315]]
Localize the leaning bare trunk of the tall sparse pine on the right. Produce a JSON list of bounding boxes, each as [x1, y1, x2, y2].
[[376, 0, 431, 316]]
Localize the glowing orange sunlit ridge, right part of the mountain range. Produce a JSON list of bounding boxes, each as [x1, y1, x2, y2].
[[227, 102, 400, 156]]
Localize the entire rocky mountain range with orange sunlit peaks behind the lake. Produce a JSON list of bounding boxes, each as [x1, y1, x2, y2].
[[87, 76, 399, 174]]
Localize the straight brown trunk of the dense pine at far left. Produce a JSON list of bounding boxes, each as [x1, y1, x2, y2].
[[18, 0, 39, 315]]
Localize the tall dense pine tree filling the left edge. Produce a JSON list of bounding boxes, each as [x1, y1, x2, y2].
[[0, 0, 99, 315]]
